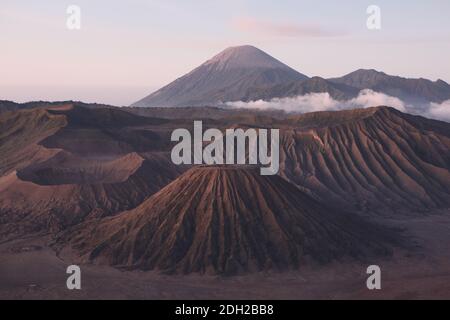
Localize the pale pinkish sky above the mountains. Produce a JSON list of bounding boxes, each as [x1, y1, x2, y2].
[[0, 0, 450, 105]]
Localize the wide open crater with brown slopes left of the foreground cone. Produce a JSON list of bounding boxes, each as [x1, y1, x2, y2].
[[0, 155, 182, 240]]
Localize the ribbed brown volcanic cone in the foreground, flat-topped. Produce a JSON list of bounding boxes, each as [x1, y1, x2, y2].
[[58, 166, 390, 274]]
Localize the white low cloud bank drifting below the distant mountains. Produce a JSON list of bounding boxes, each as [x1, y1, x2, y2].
[[225, 89, 450, 121]]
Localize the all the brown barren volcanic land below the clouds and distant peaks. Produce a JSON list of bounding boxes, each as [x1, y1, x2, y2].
[[0, 103, 450, 299]]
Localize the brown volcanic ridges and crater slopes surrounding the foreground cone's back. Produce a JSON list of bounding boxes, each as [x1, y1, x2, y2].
[[0, 104, 450, 246]]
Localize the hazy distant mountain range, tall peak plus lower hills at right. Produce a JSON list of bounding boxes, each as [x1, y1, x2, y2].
[[132, 46, 450, 107]]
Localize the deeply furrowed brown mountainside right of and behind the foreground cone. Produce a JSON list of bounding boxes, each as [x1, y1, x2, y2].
[[280, 107, 450, 215]]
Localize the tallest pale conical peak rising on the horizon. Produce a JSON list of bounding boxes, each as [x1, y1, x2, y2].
[[133, 46, 307, 107]]
